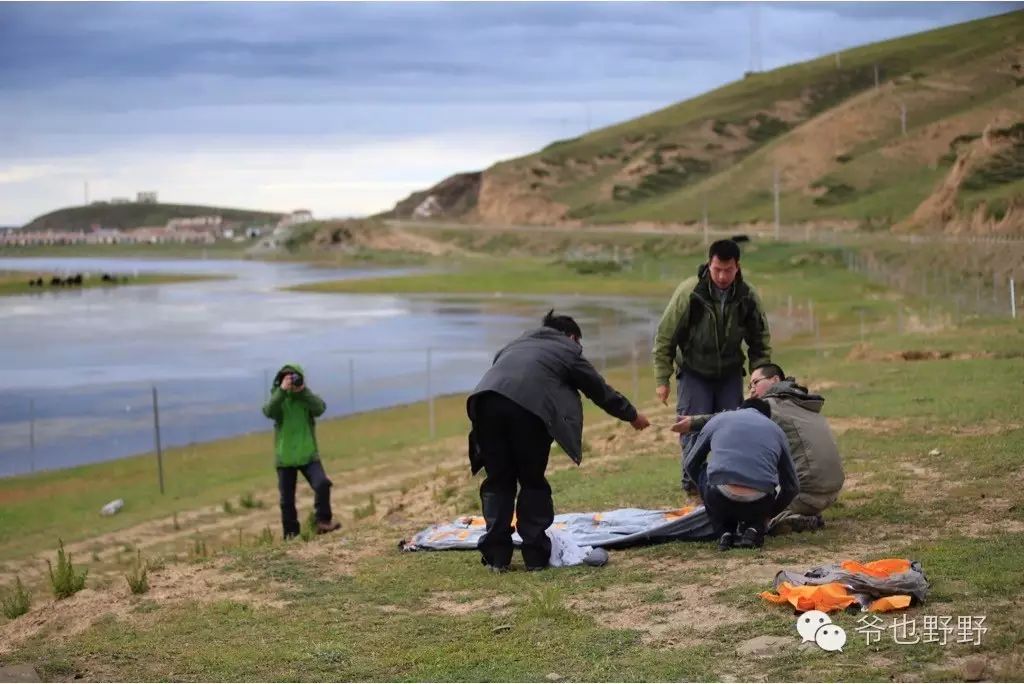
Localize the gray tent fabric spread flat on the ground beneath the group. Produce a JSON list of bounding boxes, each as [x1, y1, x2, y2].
[[399, 506, 715, 551]]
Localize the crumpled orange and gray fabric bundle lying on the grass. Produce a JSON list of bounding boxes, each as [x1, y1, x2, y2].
[[760, 558, 930, 612]]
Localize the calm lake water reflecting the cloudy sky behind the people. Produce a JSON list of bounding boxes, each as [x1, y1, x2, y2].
[[0, 259, 656, 476]]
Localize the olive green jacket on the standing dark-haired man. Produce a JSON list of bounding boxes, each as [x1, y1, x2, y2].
[[652, 263, 771, 385]]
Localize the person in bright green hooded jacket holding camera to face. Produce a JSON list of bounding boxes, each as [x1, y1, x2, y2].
[[263, 364, 341, 539]]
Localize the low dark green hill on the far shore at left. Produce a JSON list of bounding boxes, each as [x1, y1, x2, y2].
[[24, 202, 282, 230]]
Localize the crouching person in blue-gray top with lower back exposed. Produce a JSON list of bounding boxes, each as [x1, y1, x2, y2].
[[686, 398, 800, 551]]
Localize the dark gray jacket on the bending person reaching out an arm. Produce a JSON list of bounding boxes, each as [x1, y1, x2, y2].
[[466, 328, 637, 473]]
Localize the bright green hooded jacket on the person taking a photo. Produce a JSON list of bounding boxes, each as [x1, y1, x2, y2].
[[263, 364, 327, 468]]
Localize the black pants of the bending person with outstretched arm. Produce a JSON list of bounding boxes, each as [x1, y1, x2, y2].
[[473, 392, 555, 567]]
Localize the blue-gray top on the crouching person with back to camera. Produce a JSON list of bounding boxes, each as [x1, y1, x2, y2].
[[686, 409, 800, 515]]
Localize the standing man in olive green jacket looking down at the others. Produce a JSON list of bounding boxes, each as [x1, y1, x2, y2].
[[653, 240, 771, 491]]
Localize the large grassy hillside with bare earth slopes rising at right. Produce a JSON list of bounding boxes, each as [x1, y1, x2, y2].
[[389, 11, 1024, 229]]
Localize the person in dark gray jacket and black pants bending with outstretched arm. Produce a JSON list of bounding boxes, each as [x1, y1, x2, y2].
[[466, 310, 650, 572]]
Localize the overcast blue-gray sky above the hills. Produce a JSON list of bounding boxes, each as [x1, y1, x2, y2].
[[0, 2, 1024, 225]]
